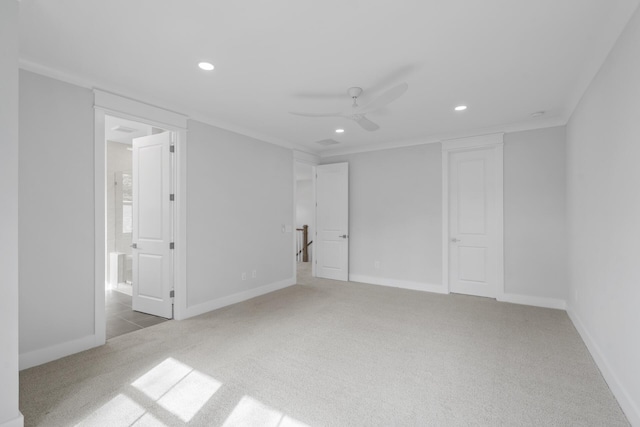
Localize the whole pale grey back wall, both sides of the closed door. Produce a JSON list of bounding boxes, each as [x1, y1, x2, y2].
[[322, 127, 568, 307]]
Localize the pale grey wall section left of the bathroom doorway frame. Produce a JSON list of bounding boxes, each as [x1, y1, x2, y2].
[[19, 70, 95, 357]]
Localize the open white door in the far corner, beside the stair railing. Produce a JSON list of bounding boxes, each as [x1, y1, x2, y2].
[[316, 163, 349, 281]]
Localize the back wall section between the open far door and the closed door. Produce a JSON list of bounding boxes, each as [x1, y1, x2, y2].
[[322, 144, 442, 290]]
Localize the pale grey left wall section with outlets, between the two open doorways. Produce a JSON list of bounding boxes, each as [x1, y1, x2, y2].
[[187, 121, 295, 315]]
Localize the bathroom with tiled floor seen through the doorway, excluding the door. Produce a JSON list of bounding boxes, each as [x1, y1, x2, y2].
[[105, 115, 172, 339]]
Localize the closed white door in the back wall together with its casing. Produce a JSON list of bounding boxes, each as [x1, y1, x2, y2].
[[443, 134, 504, 298]]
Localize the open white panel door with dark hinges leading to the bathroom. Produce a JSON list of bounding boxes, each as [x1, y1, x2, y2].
[[132, 132, 173, 319]]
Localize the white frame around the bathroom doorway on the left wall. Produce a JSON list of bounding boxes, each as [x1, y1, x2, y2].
[[93, 89, 187, 345]]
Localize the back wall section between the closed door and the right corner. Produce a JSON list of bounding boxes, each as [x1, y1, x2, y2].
[[504, 127, 568, 301]]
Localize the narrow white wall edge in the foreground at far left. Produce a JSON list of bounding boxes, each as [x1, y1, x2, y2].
[[0, 0, 23, 427]]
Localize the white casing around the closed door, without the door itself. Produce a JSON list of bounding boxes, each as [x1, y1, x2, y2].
[[442, 133, 504, 301]]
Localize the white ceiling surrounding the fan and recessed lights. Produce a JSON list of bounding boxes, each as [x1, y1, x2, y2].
[[20, 0, 638, 155]]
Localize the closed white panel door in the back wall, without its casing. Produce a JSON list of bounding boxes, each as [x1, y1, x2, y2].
[[449, 148, 498, 298]]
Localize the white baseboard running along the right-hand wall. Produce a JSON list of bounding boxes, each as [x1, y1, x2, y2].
[[567, 305, 640, 426]]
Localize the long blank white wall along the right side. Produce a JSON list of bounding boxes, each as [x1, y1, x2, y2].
[[567, 3, 640, 425]]
